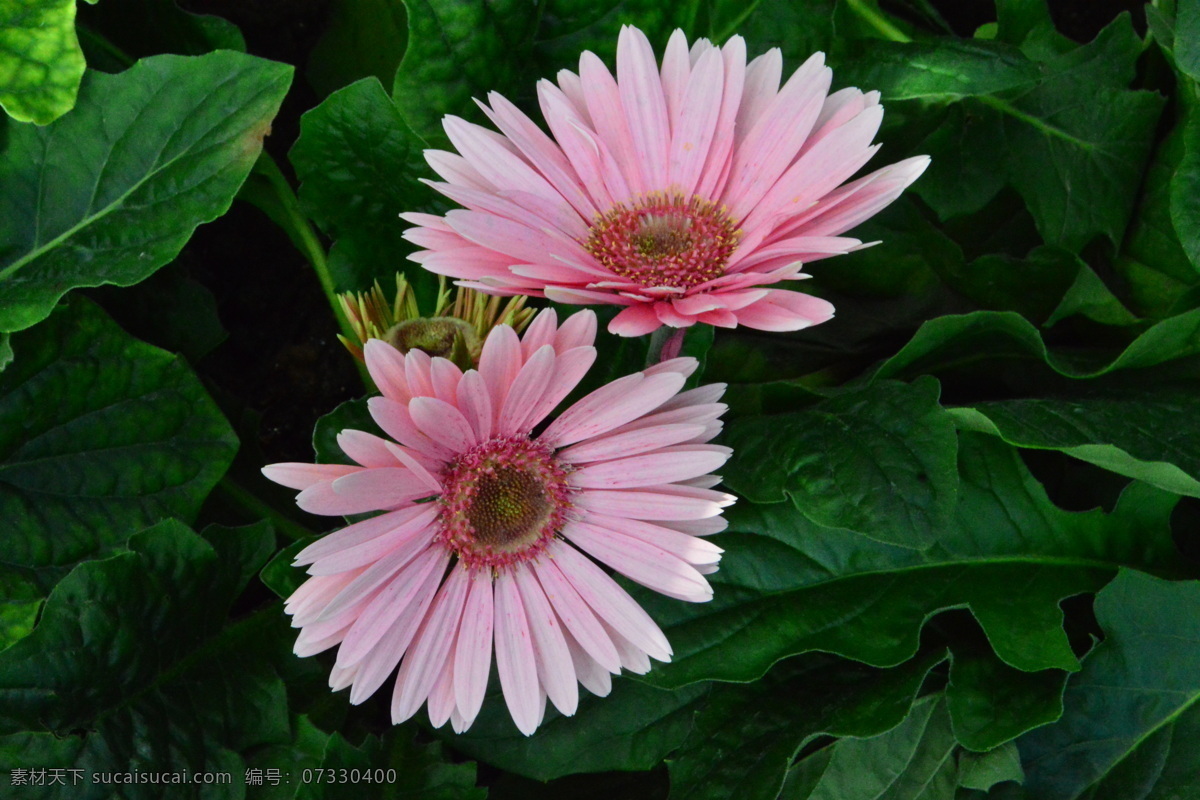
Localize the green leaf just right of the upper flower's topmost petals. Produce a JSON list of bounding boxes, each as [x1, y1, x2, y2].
[[836, 38, 1040, 103]]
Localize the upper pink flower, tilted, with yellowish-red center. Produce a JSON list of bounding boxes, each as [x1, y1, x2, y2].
[[401, 26, 929, 336]]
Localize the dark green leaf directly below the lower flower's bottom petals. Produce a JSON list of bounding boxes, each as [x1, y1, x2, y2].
[[444, 679, 708, 781]]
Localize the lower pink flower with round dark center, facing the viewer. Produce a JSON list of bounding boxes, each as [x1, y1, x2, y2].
[[263, 309, 733, 734]]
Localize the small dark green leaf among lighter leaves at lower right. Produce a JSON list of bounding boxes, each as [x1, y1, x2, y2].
[[946, 643, 1069, 753]]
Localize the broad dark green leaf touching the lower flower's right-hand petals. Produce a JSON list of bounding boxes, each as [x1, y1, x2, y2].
[[725, 379, 958, 548]]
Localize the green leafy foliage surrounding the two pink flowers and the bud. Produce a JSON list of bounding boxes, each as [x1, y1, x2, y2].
[[0, 0, 1200, 800]]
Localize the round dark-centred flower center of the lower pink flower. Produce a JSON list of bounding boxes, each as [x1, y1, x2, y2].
[[438, 435, 570, 567]]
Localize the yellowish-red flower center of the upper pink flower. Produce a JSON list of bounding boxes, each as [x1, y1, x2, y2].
[[583, 192, 742, 289]]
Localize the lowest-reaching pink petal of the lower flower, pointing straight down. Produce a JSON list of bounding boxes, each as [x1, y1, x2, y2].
[[496, 570, 540, 736]]
